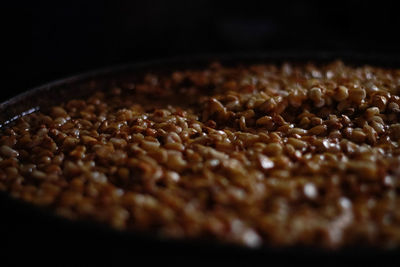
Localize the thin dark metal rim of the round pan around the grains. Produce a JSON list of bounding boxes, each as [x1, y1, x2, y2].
[[0, 51, 400, 257]]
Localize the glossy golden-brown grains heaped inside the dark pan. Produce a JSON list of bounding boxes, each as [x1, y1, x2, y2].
[[0, 61, 400, 248]]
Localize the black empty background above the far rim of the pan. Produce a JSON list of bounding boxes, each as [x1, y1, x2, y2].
[[1, 0, 400, 103]]
